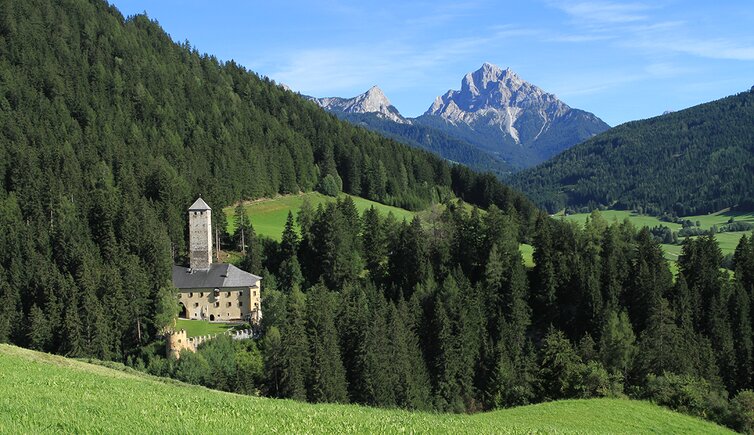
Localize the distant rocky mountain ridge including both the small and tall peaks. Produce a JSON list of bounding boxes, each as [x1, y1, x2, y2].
[[310, 63, 610, 172]]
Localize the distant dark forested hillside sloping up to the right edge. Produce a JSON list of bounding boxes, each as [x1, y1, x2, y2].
[[509, 91, 754, 216]]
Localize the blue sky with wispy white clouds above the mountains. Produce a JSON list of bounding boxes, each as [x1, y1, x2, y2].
[[107, 0, 754, 125]]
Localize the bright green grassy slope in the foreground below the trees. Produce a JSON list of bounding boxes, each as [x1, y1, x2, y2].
[[0, 344, 730, 434]]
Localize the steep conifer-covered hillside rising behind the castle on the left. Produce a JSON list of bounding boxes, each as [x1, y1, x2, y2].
[[0, 0, 536, 359]]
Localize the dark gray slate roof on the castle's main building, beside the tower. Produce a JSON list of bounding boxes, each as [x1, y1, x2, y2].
[[173, 263, 262, 289]]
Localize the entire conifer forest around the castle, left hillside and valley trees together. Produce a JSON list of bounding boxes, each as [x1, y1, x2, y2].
[[0, 0, 754, 428]]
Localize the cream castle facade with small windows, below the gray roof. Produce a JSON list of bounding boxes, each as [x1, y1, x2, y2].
[[180, 282, 262, 323]]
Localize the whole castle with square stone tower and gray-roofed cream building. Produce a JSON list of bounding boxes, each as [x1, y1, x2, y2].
[[173, 198, 262, 323]]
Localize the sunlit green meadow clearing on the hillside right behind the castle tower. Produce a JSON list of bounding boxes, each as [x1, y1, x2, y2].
[[223, 192, 414, 240]]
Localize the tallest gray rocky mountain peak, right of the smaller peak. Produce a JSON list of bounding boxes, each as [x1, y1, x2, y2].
[[416, 63, 609, 167]]
